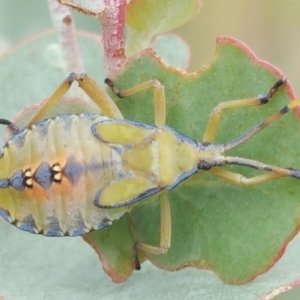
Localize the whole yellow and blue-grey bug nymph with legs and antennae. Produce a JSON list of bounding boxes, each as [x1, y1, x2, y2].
[[0, 73, 300, 269]]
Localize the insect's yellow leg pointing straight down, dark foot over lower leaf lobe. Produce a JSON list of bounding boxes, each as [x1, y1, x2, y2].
[[133, 192, 171, 270]]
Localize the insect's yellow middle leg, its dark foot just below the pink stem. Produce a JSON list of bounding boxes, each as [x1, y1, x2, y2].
[[105, 78, 166, 127]]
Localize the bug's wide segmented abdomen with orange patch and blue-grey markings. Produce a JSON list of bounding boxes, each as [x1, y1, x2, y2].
[[0, 114, 127, 236]]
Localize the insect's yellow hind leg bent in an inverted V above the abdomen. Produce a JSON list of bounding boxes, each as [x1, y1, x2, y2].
[[27, 73, 123, 127]]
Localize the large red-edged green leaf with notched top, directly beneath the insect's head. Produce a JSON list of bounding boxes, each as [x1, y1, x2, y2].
[[96, 39, 300, 284]]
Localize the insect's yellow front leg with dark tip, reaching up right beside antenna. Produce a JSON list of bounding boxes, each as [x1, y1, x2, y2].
[[203, 79, 286, 143]]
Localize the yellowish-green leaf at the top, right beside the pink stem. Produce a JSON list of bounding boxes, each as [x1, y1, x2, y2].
[[126, 0, 201, 56]]
